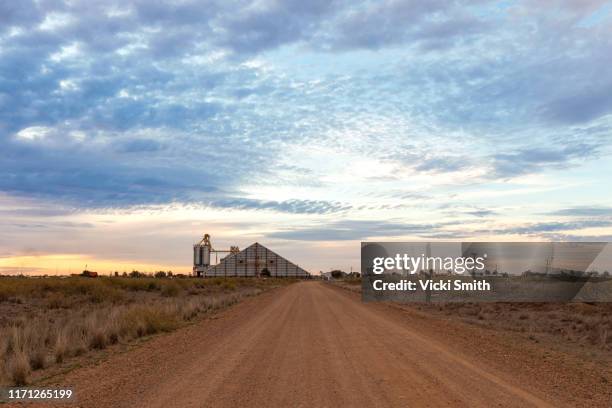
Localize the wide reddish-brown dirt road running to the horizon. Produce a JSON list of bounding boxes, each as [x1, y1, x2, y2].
[[41, 282, 601, 407]]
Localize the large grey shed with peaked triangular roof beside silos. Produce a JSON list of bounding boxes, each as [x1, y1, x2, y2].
[[202, 242, 310, 278]]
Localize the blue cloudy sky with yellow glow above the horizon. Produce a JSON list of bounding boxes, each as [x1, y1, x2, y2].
[[0, 0, 612, 273]]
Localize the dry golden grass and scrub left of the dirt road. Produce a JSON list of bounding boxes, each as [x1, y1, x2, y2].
[[0, 276, 290, 385]]
